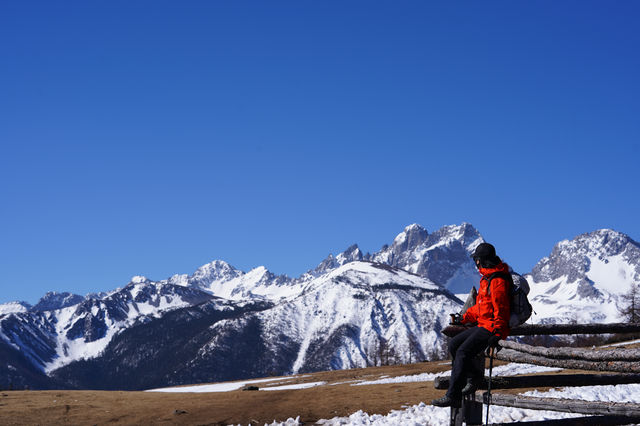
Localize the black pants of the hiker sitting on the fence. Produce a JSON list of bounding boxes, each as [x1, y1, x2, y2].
[[447, 326, 492, 399]]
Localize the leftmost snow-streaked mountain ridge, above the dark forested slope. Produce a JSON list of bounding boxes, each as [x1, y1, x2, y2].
[[0, 277, 212, 371]]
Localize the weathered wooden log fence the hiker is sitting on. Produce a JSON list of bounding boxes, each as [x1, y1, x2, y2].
[[434, 324, 640, 426]]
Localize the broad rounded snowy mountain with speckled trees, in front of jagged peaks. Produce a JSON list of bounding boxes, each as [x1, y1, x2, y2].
[[257, 261, 461, 373]]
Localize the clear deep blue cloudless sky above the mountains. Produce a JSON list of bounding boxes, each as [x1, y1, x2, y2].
[[0, 1, 640, 303]]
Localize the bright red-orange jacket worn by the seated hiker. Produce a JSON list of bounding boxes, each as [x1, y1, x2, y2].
[[462, 263, 511, 339]]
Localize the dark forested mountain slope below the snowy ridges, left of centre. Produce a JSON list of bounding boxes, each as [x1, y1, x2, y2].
[[50, 299, 272, 390]]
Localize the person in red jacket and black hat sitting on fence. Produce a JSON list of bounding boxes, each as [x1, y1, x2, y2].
[[431, 243, 511, 407]]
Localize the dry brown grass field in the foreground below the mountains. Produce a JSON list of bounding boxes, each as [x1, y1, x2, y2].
[[5, 341, 640, 425]]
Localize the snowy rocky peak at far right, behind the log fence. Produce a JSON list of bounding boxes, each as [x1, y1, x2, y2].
[[527, 229, 640, 323]]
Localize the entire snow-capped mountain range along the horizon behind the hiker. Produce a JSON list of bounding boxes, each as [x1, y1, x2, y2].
[[0, 223, 640, 389]]
